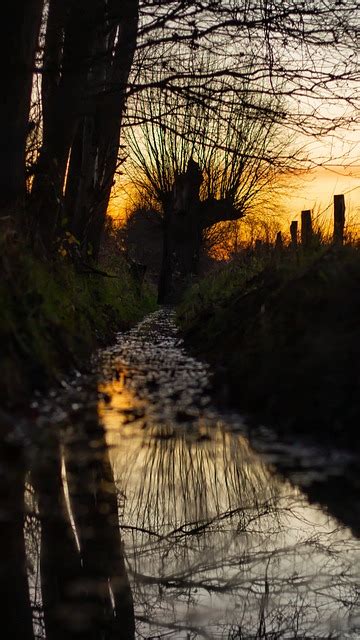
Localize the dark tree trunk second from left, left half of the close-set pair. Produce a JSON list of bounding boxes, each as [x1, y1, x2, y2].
[[32, 0, 103, 248]]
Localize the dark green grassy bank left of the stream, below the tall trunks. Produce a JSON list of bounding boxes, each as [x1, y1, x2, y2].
[[0, 232, 155, 406]]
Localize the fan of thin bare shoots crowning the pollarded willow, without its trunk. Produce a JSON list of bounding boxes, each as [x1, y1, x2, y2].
[[124, 65, 300, 215]]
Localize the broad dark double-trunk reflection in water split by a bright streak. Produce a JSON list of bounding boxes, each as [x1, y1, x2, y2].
[[27, 404, 134, 640]]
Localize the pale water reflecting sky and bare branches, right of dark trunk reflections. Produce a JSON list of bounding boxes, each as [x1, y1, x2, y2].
[[110, 424, 358, 639]]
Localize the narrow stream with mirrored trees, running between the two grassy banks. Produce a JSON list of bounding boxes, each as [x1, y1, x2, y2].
[[0, 309, 360, 640]]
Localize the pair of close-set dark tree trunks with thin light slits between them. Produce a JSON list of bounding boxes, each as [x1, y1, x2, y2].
[[32, 0, 138, 255]]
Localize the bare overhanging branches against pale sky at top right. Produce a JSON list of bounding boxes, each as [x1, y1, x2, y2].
[[130, 0, 359, 133]]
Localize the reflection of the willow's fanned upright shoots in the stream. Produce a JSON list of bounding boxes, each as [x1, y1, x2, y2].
[[112, 429, 280, 533]]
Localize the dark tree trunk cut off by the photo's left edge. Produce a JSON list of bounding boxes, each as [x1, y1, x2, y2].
[[0, 0, 43, 218]]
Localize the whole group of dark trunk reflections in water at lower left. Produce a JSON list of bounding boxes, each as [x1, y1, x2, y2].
[[0, 404, 134, 640]]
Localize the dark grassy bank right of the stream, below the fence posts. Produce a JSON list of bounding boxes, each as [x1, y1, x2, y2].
[[178, 247, 360, 444]]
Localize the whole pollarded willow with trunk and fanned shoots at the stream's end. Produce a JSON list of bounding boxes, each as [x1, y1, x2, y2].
[[124, 57, 299, 301]]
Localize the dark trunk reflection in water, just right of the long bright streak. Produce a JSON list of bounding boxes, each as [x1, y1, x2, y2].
[[65, 420, 134, 640]]
